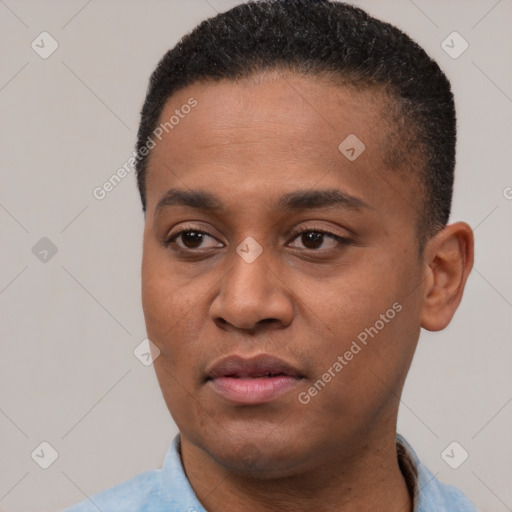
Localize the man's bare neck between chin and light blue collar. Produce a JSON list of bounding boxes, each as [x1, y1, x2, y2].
[[181, 436, 412, 512]]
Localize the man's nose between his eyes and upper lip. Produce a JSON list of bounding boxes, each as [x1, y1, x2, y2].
[[210, 244, 294, 331]]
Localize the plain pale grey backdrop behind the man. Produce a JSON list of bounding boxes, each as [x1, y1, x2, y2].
[[0, 0, 512, 512]]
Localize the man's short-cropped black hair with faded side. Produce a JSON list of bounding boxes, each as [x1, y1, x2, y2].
[[136, 0, 456, 242]]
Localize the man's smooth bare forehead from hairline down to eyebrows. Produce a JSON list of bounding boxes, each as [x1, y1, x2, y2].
[[143, 72, 416, 222]]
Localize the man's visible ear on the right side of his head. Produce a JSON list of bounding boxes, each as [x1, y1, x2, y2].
[[421, 222, 474, 331]]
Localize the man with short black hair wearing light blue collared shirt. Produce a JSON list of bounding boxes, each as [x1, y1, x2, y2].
[[63, 0, 475, 512]]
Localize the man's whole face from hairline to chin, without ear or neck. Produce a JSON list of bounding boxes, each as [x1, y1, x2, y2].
[[142, 73, 425, 477]]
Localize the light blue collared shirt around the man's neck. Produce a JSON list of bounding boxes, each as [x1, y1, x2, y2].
[[63, 434, 477, 512]]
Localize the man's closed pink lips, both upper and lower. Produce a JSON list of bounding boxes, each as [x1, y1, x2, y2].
[[206, 354, 305, 405]]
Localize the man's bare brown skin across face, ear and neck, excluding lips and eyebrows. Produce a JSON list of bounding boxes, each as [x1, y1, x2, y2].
[[142, 72, 473, 512]]
